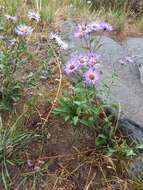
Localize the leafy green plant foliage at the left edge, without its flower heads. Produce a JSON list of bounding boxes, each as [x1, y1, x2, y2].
[[0, 40, 29, 111]]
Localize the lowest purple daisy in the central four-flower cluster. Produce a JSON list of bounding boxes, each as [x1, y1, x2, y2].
[[84, 68, 100, 86]]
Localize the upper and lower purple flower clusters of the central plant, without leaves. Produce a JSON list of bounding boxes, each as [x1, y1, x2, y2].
[[64, 22, 113, 86]]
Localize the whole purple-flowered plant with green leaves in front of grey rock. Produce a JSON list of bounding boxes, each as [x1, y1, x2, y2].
[[54, 22, 139, 156]]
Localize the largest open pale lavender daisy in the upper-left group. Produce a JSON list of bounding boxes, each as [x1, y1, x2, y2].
[[15, 24, 33, 37]]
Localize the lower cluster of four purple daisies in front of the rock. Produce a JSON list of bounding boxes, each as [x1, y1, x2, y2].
[[64, 52, 100, 85]]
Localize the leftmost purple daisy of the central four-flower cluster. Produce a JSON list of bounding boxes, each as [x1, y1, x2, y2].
[[64, 58, 79, 75]]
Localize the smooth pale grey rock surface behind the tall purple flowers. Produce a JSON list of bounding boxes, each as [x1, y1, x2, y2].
[[61, 21, 143, 142]]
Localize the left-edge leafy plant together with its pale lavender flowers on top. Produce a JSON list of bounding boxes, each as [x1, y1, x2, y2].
[[0, 11, 40, 112]]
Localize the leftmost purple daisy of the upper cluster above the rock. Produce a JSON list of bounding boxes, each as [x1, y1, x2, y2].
[[75, 24, 92, 38]]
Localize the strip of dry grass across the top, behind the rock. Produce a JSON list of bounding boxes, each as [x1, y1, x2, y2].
[[0, 0, 143, 35]]
